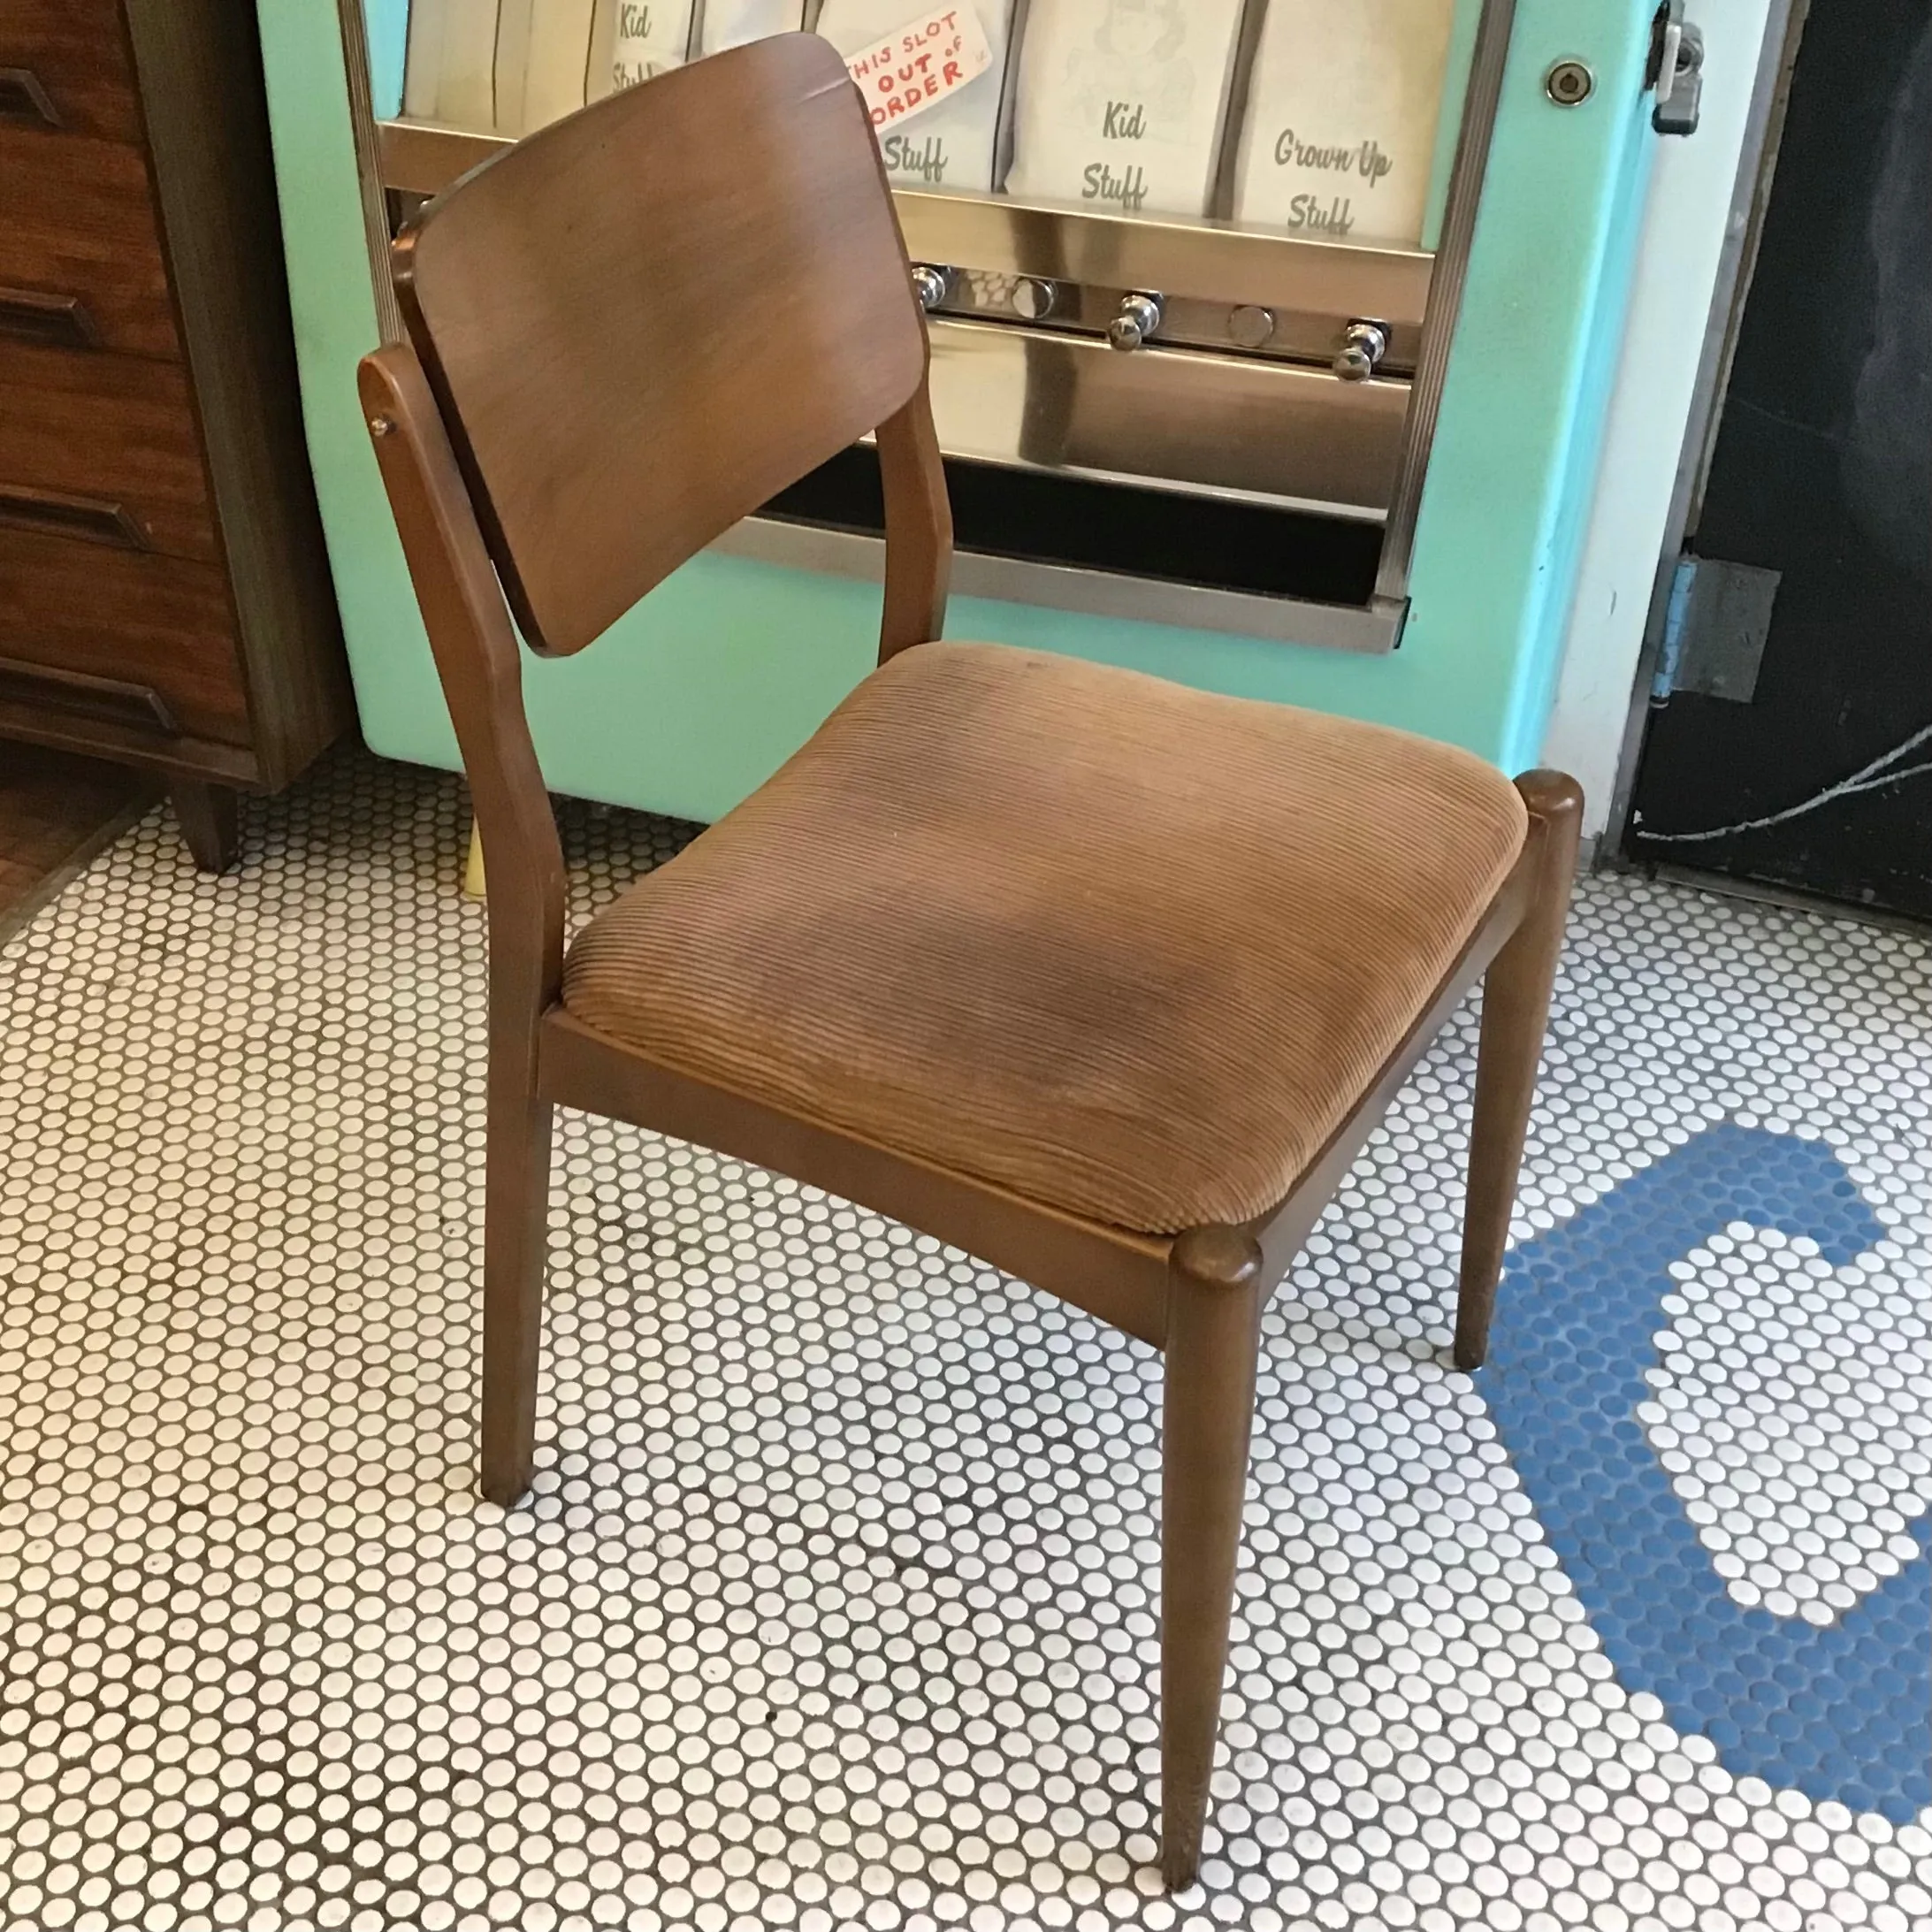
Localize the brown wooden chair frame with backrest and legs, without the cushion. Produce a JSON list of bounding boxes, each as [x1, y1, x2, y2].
[[362, 34, 1580, 1888]]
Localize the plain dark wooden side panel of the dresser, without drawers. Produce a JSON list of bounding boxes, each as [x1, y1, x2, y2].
[[126, 0, 354, 786]]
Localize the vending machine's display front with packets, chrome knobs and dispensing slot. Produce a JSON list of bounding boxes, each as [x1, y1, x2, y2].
[[359, 0, 1513, 651]]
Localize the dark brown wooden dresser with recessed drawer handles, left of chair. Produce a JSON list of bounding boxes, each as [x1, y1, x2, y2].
[[0, 0, 354, 869]]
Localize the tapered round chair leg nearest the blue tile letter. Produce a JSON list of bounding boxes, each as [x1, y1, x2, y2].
[[1455, 771, 1583, 1368]]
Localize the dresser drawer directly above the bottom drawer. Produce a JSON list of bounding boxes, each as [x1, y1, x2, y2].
[[0, 338, 220, 564]]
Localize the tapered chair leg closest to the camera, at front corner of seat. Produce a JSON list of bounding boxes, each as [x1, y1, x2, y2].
[[1161, 1226, 1264, 1891]]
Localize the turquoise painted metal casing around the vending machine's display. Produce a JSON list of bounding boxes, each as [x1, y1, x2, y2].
[[259, 0, 1652, 817]]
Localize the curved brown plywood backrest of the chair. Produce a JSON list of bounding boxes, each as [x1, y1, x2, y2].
[[396, 33, 928, 655]]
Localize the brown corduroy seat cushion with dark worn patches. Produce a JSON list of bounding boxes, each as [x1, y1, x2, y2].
[[564, 644, 1526, 1233]]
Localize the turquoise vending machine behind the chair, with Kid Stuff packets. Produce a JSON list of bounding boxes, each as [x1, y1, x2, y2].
[[259, 0, 1694, 819]]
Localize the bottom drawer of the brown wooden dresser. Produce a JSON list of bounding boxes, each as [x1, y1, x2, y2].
[[0, 525, 249, 750]]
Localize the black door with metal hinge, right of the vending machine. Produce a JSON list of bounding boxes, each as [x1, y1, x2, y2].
[[1625, 0, 1932, 918]]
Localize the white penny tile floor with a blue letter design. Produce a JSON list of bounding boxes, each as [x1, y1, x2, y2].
[[0, 760, 1932, 1932]]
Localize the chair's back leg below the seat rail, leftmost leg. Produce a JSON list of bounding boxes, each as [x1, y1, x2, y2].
[[483, 1074, 551, 1508]]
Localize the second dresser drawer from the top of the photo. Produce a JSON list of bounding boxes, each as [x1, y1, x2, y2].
[[0, 126, 179, 357]]
